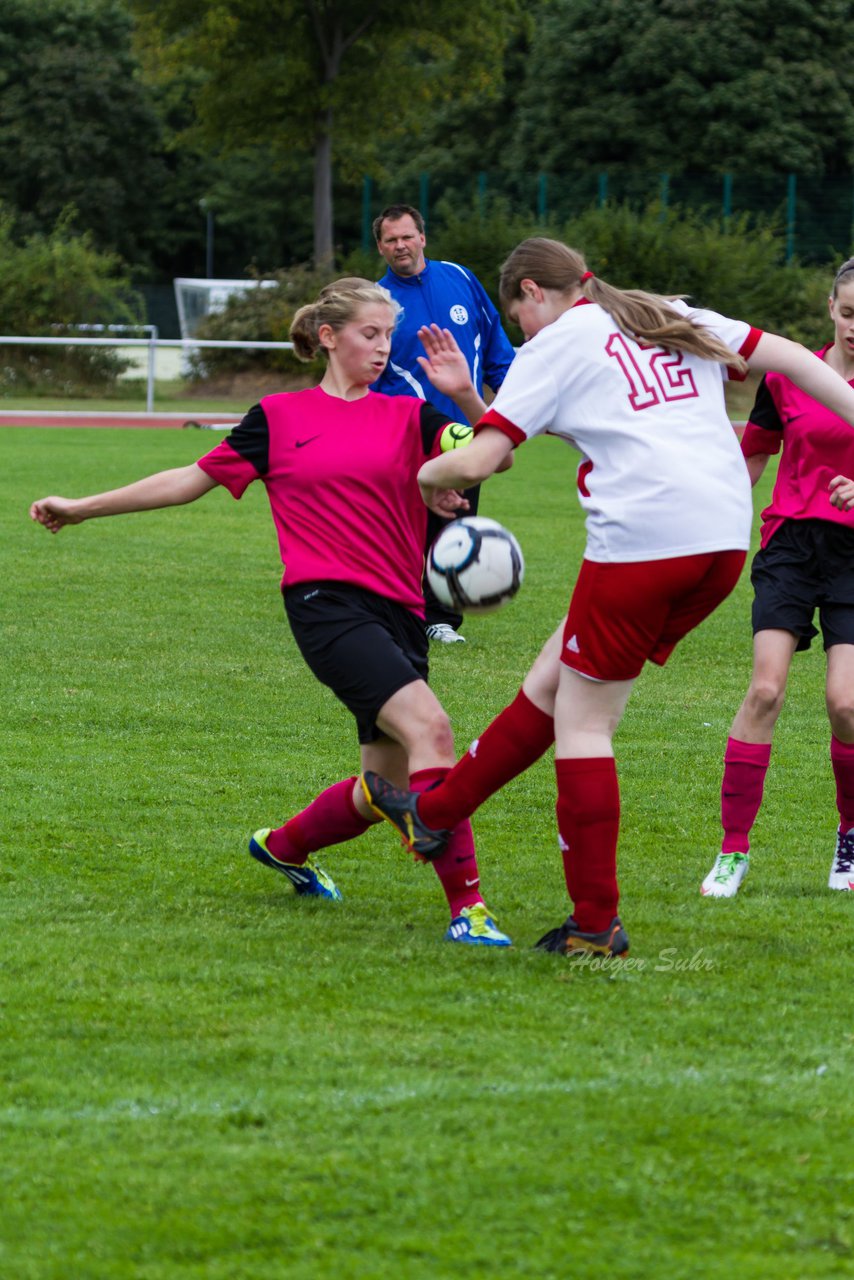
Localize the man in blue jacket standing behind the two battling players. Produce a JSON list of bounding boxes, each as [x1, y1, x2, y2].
[[374, 205, 515, 644]]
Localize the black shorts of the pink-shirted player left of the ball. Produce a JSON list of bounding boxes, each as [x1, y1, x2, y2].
[[284, 582, 429, 744]]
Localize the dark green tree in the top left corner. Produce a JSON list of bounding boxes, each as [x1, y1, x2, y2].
[[0, 0, 164, 261]]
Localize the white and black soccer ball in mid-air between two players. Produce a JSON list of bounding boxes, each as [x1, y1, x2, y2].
[[426, 516, 525, 613]]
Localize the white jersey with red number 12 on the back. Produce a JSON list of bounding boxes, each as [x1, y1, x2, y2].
[[479, 298, 762, 562]]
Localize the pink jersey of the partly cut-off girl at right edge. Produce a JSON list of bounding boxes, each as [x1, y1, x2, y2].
[[741, 343, 854, 547]]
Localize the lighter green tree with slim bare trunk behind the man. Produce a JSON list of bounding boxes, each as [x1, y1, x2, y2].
[[134, 0, 519, 266]]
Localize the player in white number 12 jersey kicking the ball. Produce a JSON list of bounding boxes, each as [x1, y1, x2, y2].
[[364, 238, 854, 955]]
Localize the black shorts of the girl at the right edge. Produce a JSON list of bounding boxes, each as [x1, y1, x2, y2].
[[750, 520, 854, 650]]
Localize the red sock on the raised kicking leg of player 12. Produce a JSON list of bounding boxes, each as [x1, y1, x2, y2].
[[419, 689, 555, 829]]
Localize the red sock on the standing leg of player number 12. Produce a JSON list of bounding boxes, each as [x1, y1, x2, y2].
[[554, 755, 620, 933]]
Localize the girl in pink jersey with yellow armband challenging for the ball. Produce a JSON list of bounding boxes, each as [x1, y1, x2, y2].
[[31, 279, 510, 947]]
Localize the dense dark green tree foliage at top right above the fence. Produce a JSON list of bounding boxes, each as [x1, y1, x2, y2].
[[510, 0, 854, 175]]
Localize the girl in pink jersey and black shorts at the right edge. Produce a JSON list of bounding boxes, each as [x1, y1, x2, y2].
[[700, 259, 854, 897]]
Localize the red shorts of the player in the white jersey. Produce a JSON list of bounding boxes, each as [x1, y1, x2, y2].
[[561, 552, 746, 680]]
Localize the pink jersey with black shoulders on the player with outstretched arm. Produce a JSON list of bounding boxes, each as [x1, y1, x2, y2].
[[198, 387, 448, 617]]
